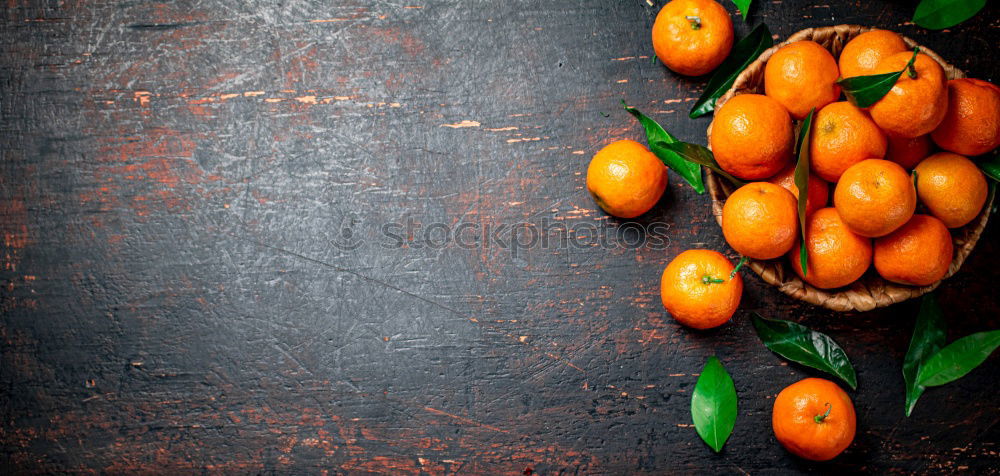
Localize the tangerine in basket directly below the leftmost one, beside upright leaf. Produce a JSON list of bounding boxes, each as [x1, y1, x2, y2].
[[722, 182, 799, 259]]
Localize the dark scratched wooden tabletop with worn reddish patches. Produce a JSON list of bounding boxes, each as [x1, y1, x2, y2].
[[0, 0, 1000, 474]]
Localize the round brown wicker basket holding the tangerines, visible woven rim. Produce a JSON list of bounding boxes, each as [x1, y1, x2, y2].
[[706, 25, 992, 312]]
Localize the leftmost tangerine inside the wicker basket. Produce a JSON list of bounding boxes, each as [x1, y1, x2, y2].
[[709, 94, 795, 180]]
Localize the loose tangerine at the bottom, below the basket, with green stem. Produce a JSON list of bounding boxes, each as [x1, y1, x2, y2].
[[771, 378, 857, 461]]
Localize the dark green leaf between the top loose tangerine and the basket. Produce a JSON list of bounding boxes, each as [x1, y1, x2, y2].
[[688, 23, 774, 119]]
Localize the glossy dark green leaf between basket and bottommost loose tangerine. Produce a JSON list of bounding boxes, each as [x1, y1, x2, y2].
[[753, 313, 858, 389]]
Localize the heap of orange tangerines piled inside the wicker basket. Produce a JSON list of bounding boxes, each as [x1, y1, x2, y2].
[[709, 30, 1000, 289]]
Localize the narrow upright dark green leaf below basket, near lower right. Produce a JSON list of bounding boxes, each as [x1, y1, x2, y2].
[[903, 293, 945, 416]]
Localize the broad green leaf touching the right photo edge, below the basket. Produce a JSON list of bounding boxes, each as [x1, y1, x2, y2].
[[917, 330, 1000, 387]]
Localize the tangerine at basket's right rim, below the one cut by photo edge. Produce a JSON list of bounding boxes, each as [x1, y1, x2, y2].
[[913, 152, 988, 228]]
